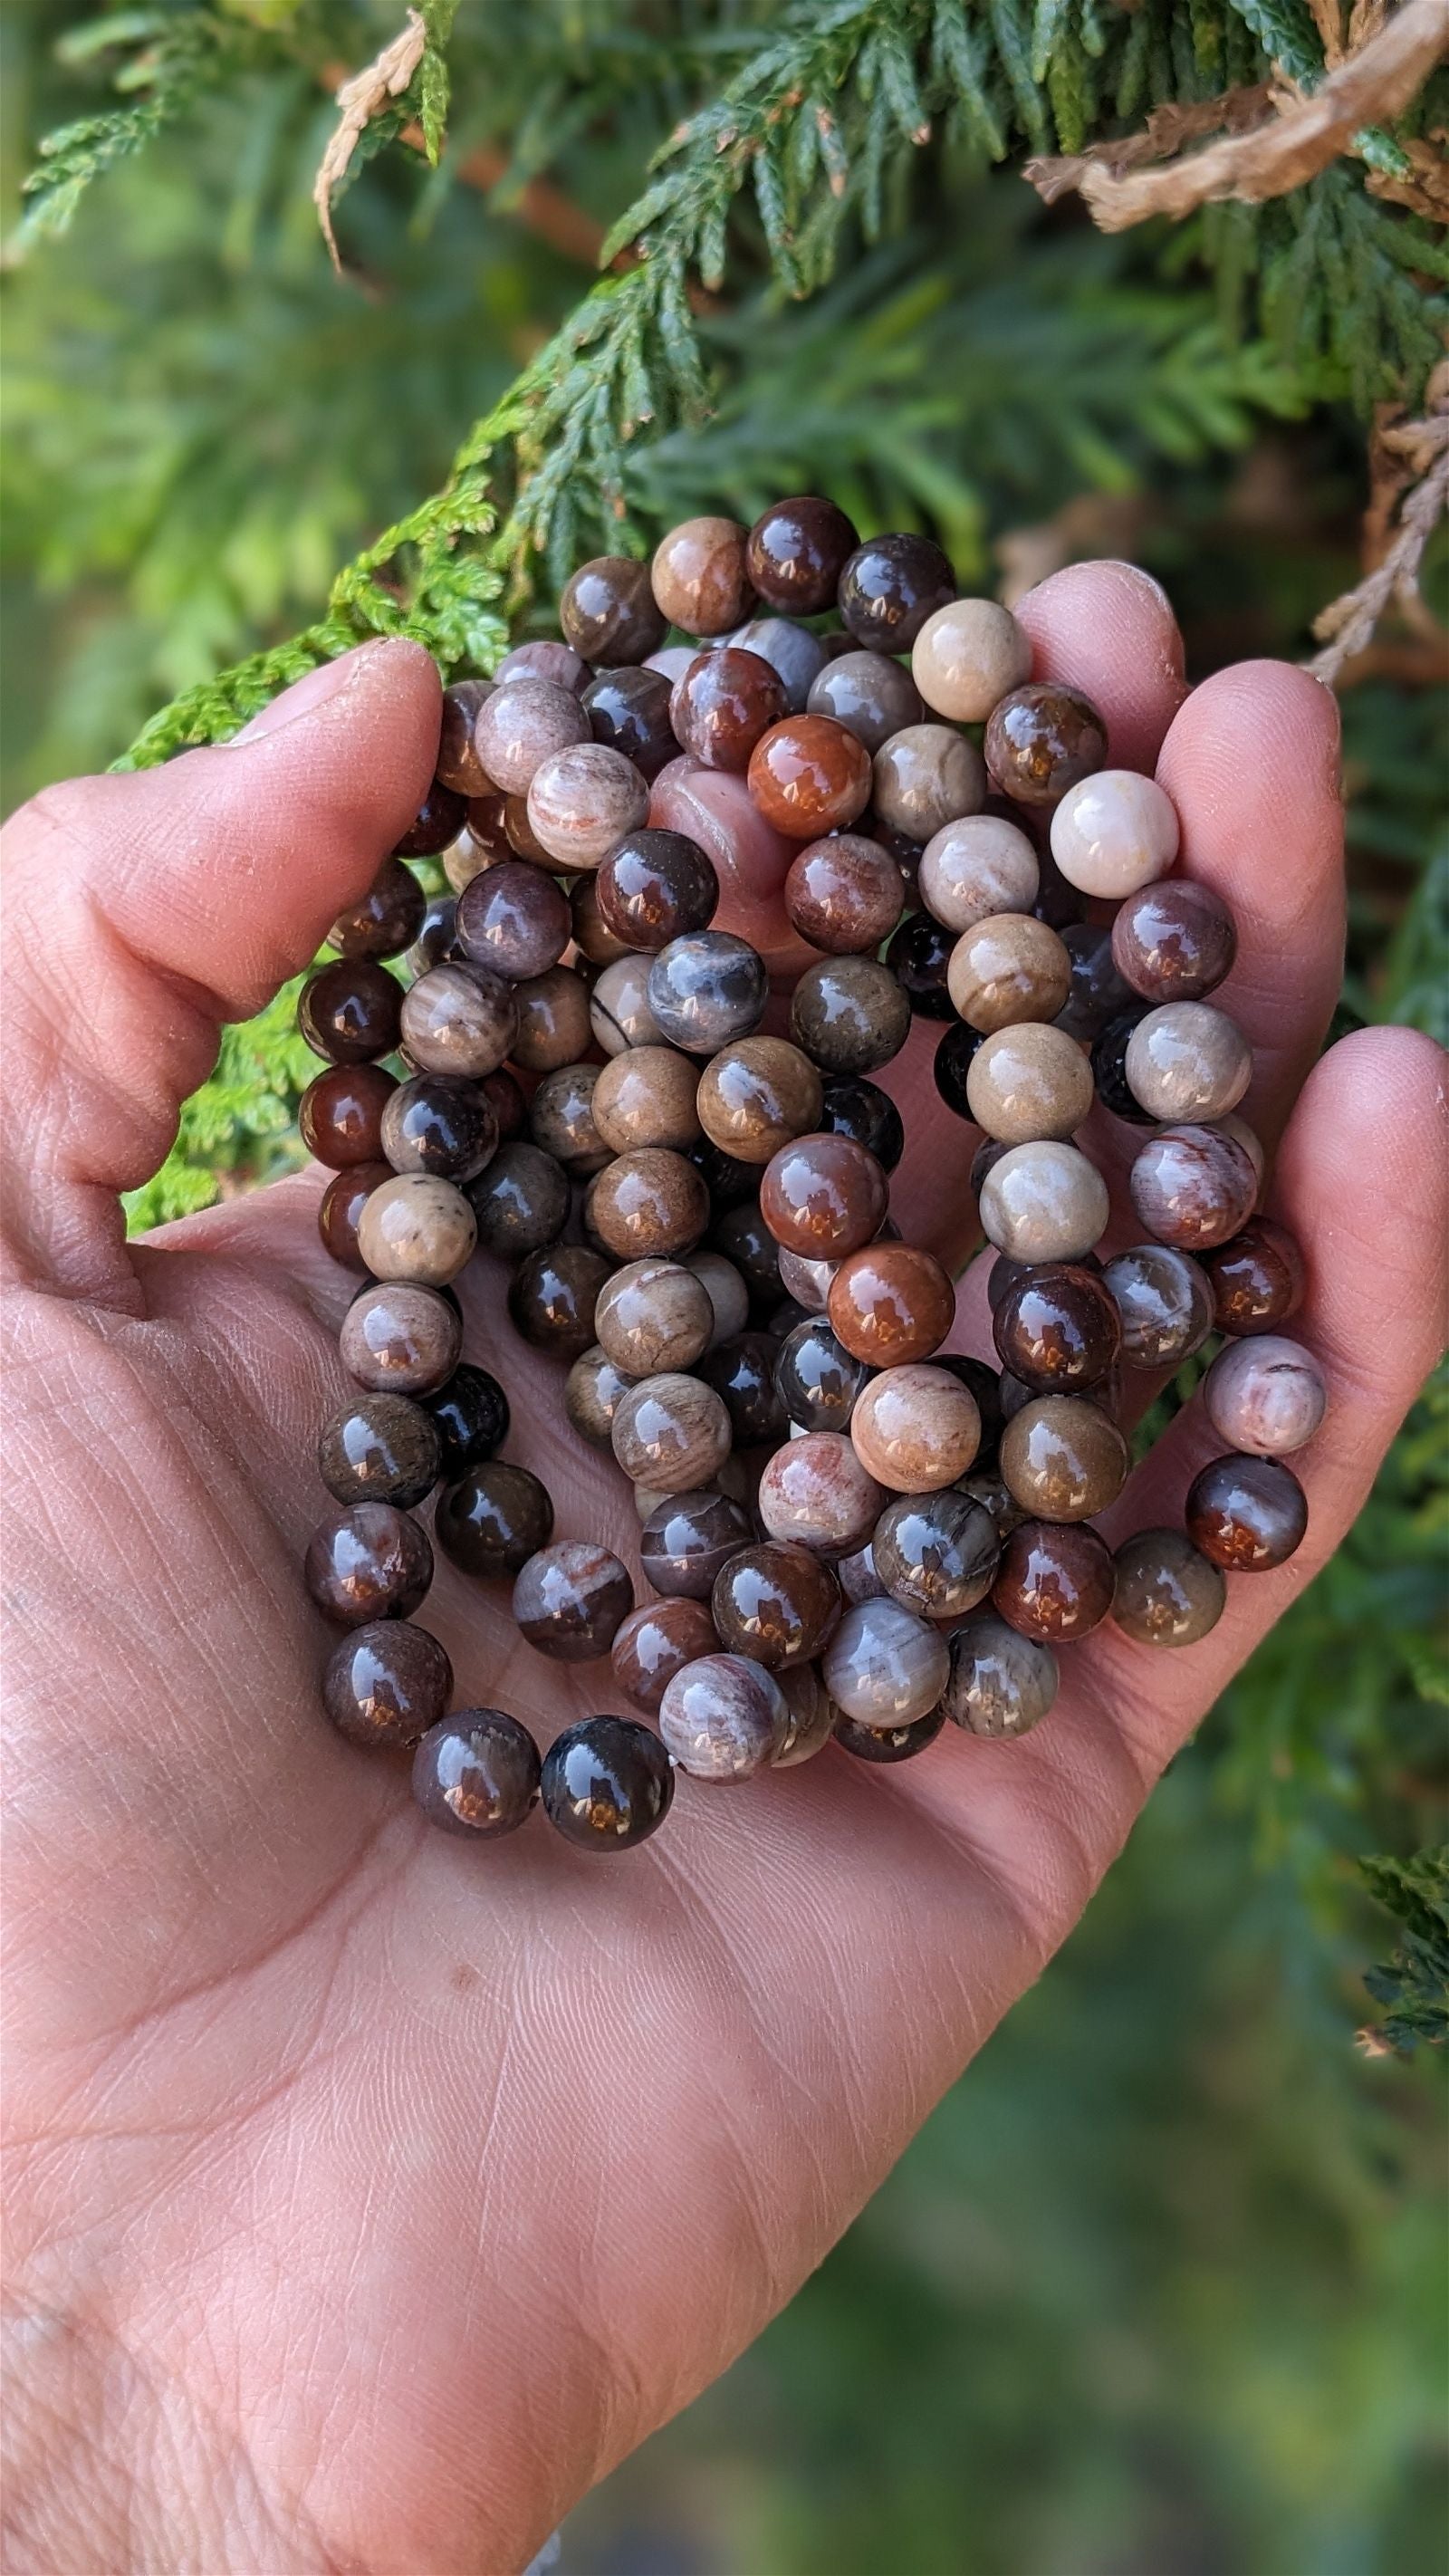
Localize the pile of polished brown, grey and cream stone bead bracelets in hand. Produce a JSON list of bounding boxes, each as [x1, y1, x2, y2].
[[299, 497, 1323, 1852]]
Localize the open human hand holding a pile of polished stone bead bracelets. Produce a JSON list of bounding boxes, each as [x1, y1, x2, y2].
[[5, 567, 1446, 2576]]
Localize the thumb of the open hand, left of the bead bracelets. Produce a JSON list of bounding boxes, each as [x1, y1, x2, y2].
[[0, 641, 440, 1303]]
